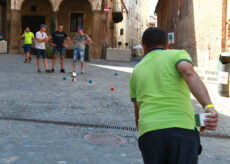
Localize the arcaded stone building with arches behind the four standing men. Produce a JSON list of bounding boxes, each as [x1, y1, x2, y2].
[[0, 0, 104, 58]]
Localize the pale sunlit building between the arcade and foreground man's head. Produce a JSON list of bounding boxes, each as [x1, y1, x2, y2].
[[115, 0, 156, 48]]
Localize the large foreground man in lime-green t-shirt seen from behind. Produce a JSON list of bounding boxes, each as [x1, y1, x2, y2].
[[130, 28, 218, 164]]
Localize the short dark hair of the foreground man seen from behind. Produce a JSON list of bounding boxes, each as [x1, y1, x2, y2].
[[142, 27, 168, 48]]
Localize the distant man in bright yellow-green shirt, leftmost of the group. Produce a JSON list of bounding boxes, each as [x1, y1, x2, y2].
[[21, 27, 35, 63]]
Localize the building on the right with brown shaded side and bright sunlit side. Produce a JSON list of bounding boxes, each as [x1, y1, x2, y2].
[[155, 0, 223, 67]]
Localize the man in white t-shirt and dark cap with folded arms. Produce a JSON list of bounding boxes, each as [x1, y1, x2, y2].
[[35, 24, 51, 73]]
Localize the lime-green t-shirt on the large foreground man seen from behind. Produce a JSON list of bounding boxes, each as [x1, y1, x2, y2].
[[130, 50, 195, 137]]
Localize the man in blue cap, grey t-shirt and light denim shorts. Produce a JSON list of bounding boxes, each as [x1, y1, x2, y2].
[[73, 26, 93, 75]]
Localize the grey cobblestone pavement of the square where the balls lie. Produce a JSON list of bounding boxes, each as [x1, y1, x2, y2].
[[0, 54, 230, 164]]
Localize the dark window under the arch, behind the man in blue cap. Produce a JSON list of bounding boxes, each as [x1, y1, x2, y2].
[[70, 13, 84, 32]]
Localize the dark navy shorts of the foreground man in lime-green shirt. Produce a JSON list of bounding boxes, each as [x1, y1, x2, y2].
[[138, 128, 201, 164]]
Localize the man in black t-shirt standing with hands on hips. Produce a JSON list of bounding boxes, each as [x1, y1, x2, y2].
[[50, 24, 70, 73]]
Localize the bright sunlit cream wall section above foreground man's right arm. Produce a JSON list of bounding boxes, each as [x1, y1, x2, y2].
[[194, 0, 222, 67]]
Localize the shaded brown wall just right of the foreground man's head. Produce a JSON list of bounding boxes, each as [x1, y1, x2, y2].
[[157, 0, 198, 65]]
